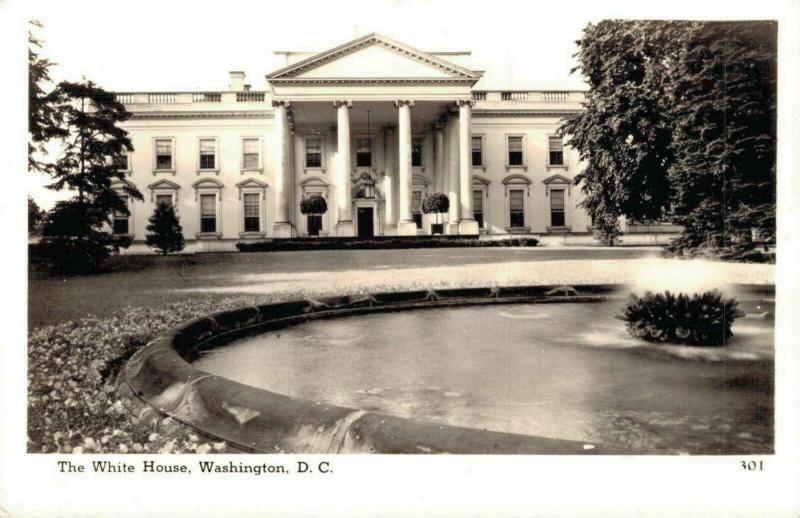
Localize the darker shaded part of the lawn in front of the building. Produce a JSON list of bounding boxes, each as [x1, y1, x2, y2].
[[28, 248, 658, 329]]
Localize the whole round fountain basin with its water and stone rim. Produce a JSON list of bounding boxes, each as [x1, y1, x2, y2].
[[115, 287, 774, 454]]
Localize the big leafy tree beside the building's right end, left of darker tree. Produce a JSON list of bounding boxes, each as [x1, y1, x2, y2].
[[561, 20, 689, 244]]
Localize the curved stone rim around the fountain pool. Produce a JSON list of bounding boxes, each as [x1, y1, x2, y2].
[[117, 285, 774, 455]]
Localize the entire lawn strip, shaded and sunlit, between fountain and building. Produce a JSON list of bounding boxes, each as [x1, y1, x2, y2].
[[28, 248, 773, 329]]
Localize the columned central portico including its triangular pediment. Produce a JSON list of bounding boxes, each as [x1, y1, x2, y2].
[[267, 34, 480, 241]]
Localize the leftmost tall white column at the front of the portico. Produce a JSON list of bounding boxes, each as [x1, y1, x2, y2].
[[272, 101, 293, 238]]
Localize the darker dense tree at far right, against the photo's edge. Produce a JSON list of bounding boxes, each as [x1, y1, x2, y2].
[[670, 22, 777, 259]]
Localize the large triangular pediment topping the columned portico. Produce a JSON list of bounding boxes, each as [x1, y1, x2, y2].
[[267, 34, 480, 81]]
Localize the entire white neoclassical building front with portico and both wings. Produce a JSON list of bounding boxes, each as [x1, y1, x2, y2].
[[114, 34, 591, 251]]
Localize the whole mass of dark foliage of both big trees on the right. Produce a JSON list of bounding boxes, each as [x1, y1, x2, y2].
[[561, 20, 777, 259]]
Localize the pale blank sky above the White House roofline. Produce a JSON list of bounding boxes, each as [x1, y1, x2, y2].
[[18, 0, 788, 207]]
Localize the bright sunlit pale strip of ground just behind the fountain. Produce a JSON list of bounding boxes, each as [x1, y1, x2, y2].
[[184, 258, 774, 295]]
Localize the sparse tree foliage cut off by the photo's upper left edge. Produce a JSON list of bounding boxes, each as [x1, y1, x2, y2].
[[28, 20, 66, 171]]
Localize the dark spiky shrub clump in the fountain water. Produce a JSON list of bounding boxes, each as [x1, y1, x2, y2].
[[618, 290, 744, 345]]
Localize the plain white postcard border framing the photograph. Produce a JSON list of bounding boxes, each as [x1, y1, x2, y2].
[[0, 0, 800, 516]]
